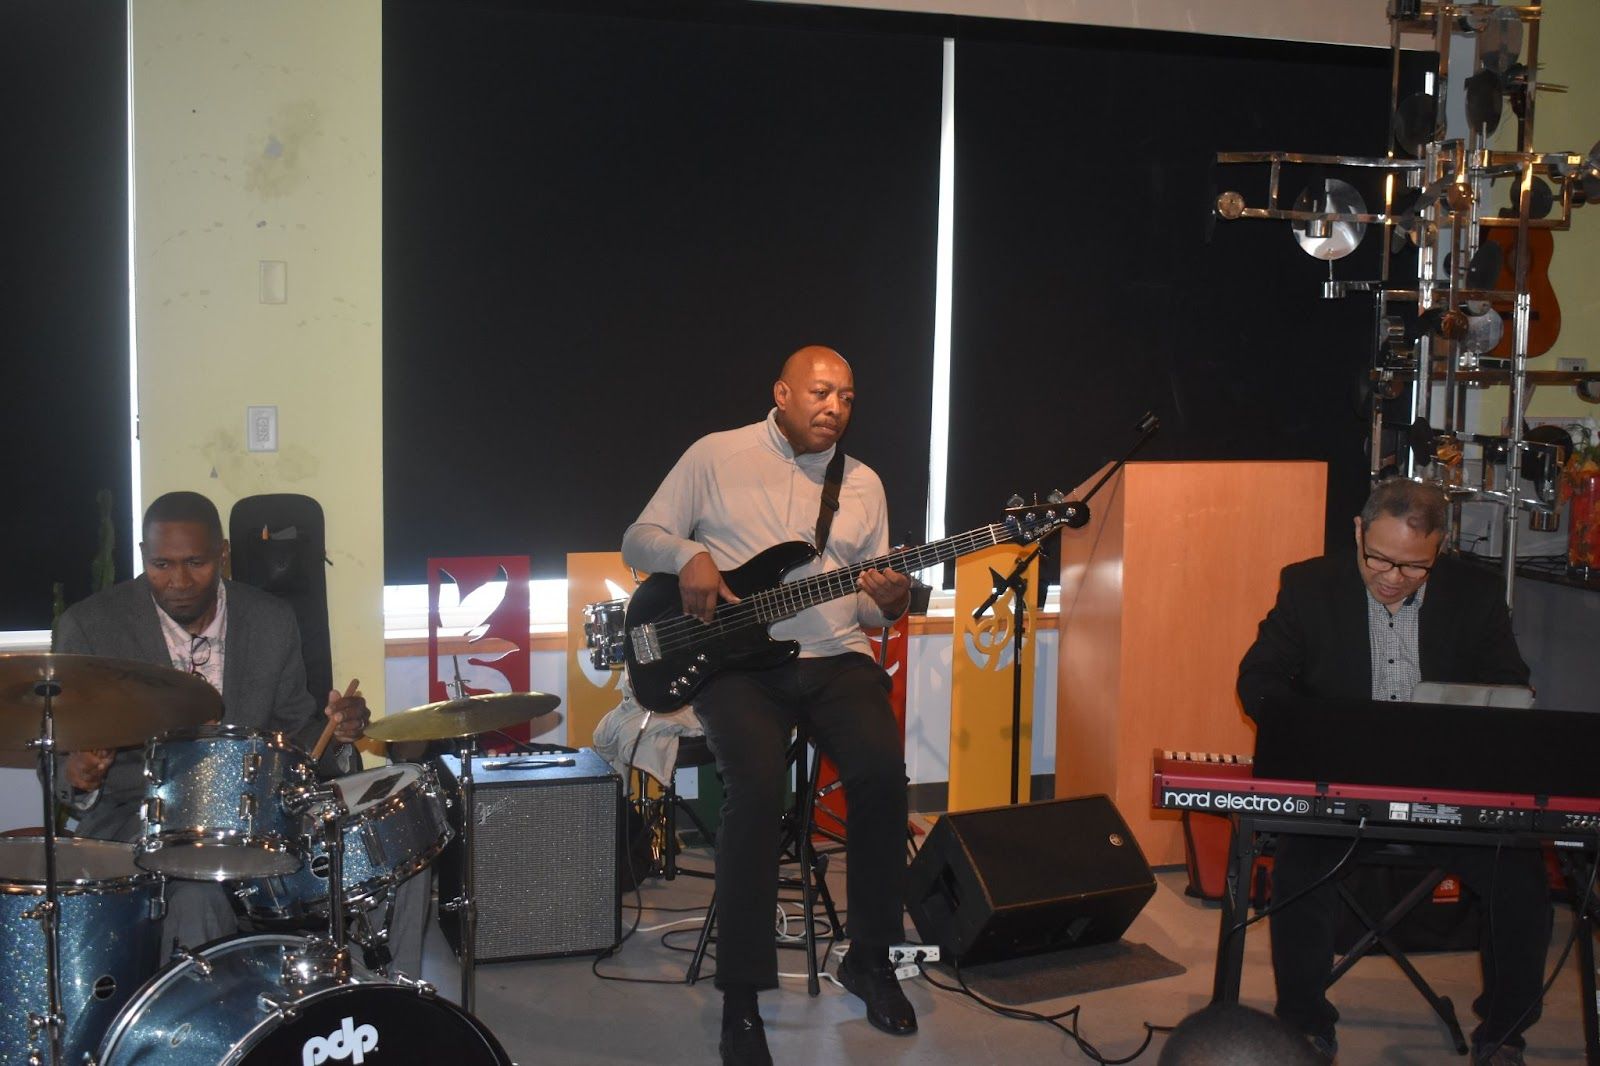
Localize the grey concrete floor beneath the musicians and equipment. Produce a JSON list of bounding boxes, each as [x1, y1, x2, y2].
[[424, 852, 1584, 1066]]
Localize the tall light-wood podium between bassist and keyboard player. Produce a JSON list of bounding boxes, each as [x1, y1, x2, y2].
[[1056, 463, 1331, 864]]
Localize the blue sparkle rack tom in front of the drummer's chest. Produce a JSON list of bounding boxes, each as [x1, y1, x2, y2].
[[134, 725, 315, 880]]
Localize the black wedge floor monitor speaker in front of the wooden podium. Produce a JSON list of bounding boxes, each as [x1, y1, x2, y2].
[[906, 795, 1155, 965]]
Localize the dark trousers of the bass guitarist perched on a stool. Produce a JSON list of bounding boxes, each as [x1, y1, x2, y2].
[[694, 653, 906, 989]]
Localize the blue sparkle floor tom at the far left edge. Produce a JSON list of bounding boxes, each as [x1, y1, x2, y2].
[[0, 837, 162, 1063]]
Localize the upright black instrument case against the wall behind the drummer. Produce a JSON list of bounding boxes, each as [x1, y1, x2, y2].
[[227, 493, 333, 707]]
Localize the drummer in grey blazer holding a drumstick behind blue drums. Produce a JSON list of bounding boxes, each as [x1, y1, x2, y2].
[[54, 491, 376, 957]]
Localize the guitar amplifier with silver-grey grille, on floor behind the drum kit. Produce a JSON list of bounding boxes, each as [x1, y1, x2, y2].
[[438, 747, 622, 962]]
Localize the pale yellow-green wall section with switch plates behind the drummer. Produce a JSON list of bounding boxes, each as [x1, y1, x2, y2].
[[131, 0, 384, 709]]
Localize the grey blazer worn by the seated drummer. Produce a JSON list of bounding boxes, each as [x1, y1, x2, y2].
[[54, 576, 344, 840]]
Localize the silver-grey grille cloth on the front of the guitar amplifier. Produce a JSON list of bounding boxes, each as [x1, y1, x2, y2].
[[474, 778, 618, 960]]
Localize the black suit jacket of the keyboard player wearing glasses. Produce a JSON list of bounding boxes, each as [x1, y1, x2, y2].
[[1238, 551, 1528, 717]]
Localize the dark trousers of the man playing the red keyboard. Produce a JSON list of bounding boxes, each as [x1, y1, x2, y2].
[[1270, 834, 1550, 1048]]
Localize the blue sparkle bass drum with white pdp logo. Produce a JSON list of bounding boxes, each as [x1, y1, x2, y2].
[[96, 933, 510, 1066]]
